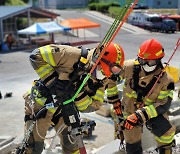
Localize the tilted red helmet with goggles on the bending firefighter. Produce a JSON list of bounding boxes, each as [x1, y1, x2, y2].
[[100, 43, 124, 77]]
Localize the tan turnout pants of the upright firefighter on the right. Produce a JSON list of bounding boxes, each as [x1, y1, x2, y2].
[[123, 115, 175, 154]]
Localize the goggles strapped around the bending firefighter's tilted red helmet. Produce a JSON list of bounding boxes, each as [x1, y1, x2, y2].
[[101, 58, 122, 75]]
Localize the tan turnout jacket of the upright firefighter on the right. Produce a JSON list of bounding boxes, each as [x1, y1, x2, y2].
[[121, 60, 174, 122]]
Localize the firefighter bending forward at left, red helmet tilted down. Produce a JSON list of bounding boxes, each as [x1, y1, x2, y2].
[[24, 43, 124, 154]]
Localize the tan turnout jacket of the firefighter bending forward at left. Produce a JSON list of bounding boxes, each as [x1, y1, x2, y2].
[[30, 44, 119, 112]]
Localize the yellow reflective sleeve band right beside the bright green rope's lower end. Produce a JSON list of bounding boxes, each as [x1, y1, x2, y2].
[[75, 96, 92, 111]]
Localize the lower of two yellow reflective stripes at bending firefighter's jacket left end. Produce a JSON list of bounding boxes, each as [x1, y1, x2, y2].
[[36, 64, 54, 78]]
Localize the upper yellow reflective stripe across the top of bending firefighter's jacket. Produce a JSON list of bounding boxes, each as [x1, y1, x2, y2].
[[39, 45, 56, 66]]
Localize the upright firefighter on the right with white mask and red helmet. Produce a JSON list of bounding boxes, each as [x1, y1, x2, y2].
[[117, 39, 175, 154]]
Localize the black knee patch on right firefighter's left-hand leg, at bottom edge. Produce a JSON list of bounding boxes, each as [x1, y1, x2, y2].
[[126, 141, 143, 154]]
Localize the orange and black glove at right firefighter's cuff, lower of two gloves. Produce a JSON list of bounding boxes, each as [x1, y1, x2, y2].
[[123, 112, 143, 130]]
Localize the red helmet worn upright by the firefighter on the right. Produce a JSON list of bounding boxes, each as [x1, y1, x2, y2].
[[138, 39, 165, 60]]
